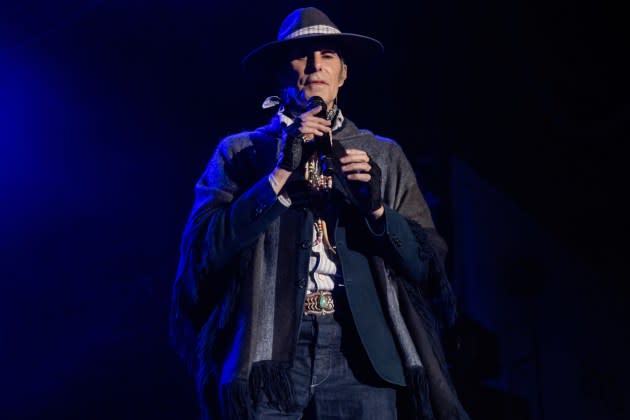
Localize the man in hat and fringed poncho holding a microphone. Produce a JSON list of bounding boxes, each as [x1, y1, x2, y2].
[[172, 7, 467, 419]]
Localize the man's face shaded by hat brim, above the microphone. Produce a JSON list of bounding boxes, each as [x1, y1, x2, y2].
[[287, 47, 347, 109]]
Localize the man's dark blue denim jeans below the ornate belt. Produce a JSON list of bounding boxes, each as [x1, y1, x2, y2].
[[254, 308, 396, 420]]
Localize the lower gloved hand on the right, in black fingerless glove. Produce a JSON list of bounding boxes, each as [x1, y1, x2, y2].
[[339, 149, 385, 219]]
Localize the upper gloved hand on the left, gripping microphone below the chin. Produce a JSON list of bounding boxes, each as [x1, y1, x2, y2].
[[277, 106, 330, 172]]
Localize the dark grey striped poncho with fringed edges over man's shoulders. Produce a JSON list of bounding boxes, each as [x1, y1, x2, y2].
[[171, 115, 468, 420]]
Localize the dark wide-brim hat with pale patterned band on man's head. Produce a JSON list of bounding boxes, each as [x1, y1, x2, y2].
[[241, 7, 384, 71]]
